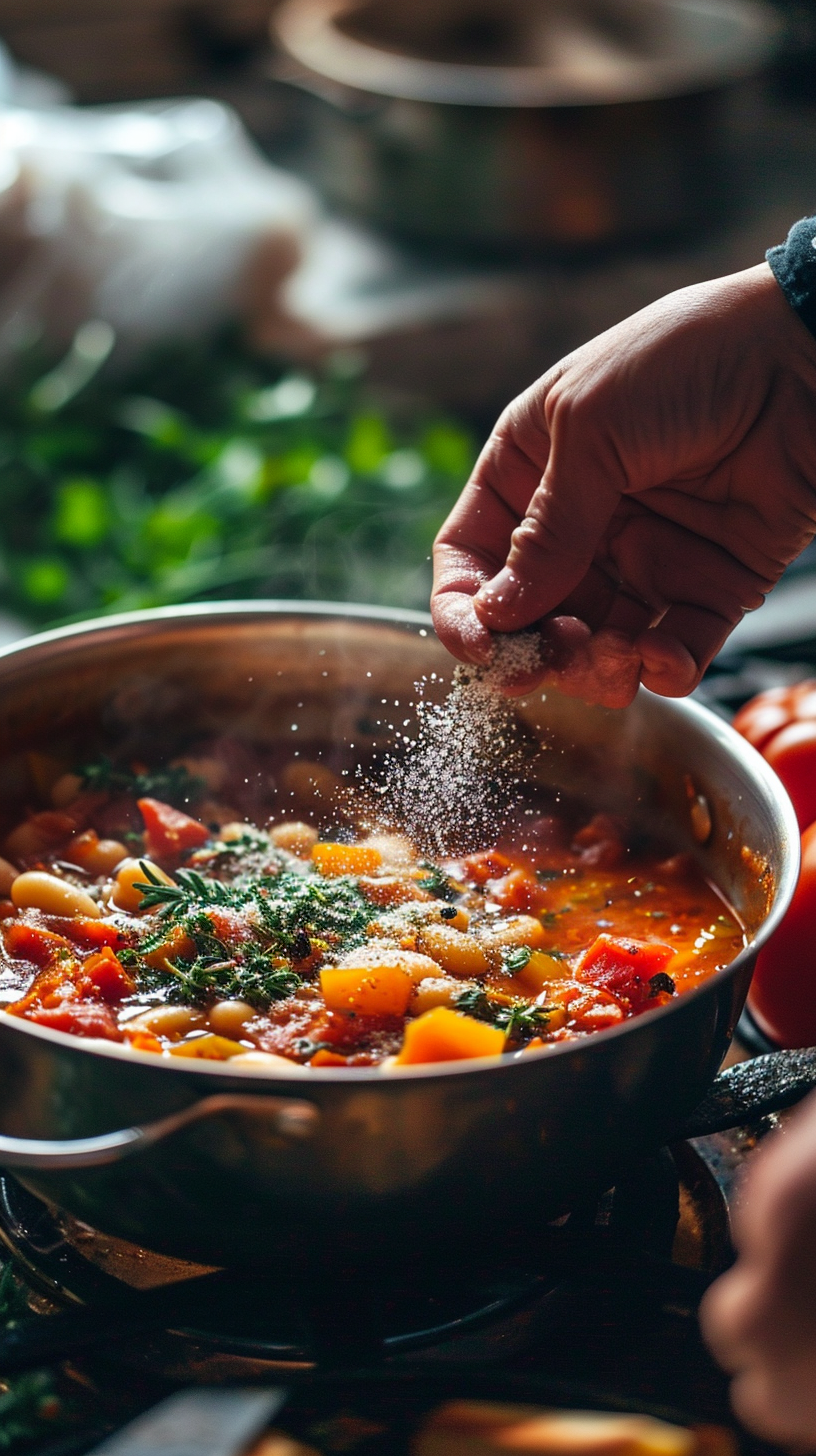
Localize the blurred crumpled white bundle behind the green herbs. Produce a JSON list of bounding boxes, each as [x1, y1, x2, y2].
[[0, 96, 319, 352]]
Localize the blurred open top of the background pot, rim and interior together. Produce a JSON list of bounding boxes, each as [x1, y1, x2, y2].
[[272, 0, 775, 106]]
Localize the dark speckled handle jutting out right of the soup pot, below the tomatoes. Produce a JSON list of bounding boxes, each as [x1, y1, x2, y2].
[[678, 1047, 816, 1139]]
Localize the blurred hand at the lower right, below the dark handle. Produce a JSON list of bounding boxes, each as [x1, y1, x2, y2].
[[701, 1095, 816, 1452]]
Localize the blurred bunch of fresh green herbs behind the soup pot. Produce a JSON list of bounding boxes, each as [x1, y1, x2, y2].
[[0, 323, 475, 626]]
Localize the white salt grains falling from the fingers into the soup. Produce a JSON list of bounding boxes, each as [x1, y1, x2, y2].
[[377, 632, 542, 855]]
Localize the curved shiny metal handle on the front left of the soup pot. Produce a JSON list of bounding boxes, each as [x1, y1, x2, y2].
[[0, 1092, 321, 1172]]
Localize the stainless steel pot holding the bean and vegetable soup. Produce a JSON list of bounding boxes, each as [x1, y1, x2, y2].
[[0, 603, 798, 1268]]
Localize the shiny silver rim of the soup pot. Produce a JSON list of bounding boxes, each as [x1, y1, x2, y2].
[[0, 598, 800, 1096]]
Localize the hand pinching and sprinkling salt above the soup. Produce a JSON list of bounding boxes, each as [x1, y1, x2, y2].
[[431, 264, 816, 708]]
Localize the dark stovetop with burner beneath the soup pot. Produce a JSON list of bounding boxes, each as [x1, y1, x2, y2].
[[0, 1089, 774, 1456]]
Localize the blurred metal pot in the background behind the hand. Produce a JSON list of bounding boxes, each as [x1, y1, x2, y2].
[[272, 0, 774, 252]]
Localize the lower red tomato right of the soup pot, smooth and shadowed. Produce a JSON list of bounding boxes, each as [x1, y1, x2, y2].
[[748, 824, 816, 1047]]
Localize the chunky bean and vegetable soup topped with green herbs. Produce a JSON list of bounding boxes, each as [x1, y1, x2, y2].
[[0, 753, 745, 1075]]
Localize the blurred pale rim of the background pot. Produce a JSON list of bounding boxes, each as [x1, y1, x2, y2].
[[271, 0, 777, 108]]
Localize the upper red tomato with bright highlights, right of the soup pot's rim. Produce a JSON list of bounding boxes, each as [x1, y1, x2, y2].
[[734, 678, 816, 830]]
